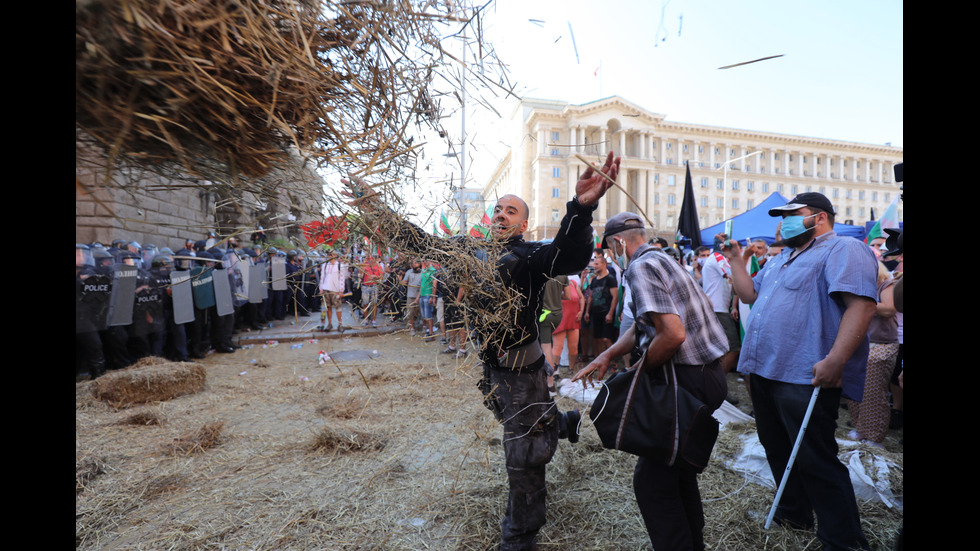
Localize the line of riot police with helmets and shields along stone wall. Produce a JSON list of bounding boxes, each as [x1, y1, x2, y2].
[[75, 239, 327, 380]]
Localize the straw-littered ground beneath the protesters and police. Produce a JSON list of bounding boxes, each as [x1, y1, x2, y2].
[[75, 332, 902, 550]]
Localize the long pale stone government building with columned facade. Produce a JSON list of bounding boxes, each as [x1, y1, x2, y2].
[[483, 96, 903, 241]]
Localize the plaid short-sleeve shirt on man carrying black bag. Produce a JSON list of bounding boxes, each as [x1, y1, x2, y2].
[[626, 245, 728, 365]]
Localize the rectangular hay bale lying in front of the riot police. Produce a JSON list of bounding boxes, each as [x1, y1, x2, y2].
[[92, 362, 207, 408]]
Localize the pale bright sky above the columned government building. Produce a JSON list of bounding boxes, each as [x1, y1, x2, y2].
[[392, 0, 904, 220]]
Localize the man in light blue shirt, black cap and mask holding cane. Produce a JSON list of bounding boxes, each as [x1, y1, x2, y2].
[[724, 193, 877, 549]]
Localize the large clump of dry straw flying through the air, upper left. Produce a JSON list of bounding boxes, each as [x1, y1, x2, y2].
[[75, 0, 498, 185]]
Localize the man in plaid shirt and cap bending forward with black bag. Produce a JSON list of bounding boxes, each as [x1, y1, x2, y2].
[[573, 212, 728, 550]]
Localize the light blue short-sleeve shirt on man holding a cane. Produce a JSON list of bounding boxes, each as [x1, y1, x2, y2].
[[738, 232, 878, 400]]
